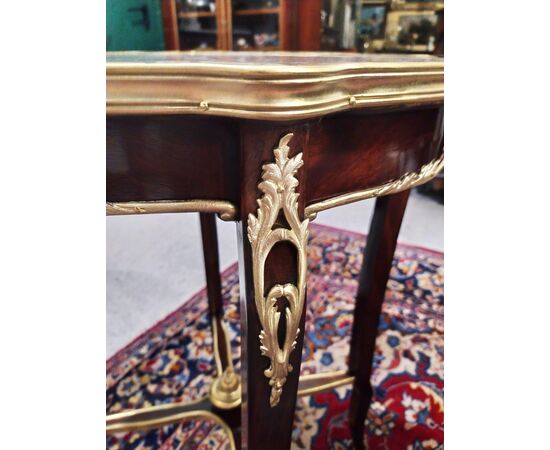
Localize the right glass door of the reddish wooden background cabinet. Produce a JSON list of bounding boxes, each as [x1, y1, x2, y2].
[[231, 0, 281, 50]]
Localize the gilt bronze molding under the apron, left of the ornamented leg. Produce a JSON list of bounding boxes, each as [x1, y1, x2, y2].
[[106, 200, 237, 221]]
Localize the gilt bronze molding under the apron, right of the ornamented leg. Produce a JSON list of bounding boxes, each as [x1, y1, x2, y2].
[[304, 153, 444, 220]]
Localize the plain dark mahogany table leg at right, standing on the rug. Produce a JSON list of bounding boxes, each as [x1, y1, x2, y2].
[[349, 190, 410, 449]]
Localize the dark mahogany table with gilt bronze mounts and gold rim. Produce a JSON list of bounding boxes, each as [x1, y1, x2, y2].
[[107, 52, 443, 449]]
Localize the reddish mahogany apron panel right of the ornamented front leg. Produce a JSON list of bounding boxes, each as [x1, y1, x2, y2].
[[306, 108, 441, 204]]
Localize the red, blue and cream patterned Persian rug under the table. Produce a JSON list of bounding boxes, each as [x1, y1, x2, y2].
[[107, 224, 443, 450]]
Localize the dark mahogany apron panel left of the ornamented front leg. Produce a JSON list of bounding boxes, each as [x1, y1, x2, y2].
[[107, 116, 239, 202]]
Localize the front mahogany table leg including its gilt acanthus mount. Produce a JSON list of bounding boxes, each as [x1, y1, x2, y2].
[[237, 124, 308, 450]]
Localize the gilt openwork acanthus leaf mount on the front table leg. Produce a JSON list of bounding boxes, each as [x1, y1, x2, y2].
[[247, 133, 309, 407]]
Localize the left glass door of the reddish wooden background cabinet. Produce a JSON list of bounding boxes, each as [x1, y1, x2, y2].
[[176, 0, 223, 50]]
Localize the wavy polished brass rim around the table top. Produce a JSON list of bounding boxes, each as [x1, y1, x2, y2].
[[107, 52, 444, 120]]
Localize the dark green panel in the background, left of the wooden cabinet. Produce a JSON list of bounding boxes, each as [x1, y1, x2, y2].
[[107, 0, 165, 51]]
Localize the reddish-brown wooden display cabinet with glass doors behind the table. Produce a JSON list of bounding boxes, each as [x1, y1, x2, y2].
[[162, 0, 321, 50]]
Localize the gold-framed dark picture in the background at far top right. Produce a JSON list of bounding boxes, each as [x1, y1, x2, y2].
[[384, 11, 437, 52]]
